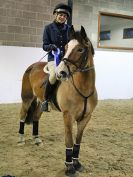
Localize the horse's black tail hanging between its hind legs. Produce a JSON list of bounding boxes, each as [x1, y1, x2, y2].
[[25, 99, 37, 124]]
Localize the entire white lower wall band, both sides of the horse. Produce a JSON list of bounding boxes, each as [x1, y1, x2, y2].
[[0, 46, 133, 103]]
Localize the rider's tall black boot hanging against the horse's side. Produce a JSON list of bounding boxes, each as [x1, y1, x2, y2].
[[41, 80, 53, 112]]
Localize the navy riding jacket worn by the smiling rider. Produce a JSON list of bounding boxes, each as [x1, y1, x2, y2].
[[43, 22, 70, 61]]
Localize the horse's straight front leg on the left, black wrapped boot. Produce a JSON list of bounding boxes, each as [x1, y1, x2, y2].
[[63, 111, 75, 176]]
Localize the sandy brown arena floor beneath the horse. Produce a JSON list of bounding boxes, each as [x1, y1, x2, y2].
[[0, 99, 133, 177]]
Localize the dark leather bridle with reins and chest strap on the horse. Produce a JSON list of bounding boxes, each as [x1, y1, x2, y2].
[[62, 47, 94, 121]]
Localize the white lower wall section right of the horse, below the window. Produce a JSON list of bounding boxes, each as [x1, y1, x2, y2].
[[94, 51, 133, 99]]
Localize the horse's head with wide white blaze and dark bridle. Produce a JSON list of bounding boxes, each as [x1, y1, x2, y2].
[[56, 26, 94, 80]]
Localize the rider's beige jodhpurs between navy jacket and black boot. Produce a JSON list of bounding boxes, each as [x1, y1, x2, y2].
[[45, 61, 56, 85]]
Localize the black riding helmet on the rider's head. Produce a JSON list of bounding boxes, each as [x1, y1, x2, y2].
[[53, 3, 72, 17]]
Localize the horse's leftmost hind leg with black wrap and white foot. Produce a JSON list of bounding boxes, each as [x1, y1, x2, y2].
[[18, 99, 32, 144]]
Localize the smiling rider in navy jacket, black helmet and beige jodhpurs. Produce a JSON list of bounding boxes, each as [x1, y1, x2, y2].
[[41, 3, 72, 111]]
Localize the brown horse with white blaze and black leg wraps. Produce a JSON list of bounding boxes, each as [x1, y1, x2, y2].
[[19, 26, 98, 176]]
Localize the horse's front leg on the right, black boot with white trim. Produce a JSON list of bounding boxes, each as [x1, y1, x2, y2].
[[73, 115, 91, 171]]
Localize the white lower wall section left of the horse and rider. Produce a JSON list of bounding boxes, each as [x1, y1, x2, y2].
[[0, 46, 45, 103]]
